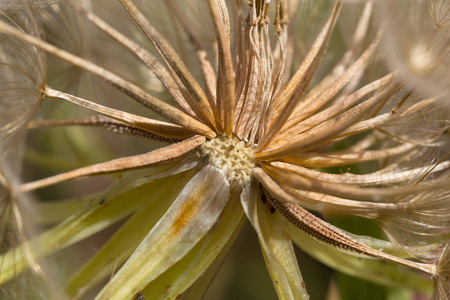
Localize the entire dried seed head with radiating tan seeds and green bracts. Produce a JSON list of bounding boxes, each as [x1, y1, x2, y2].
[[0, 0, 450, 299]]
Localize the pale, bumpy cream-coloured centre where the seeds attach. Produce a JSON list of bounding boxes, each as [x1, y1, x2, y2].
[[201, 136, 256, 184]]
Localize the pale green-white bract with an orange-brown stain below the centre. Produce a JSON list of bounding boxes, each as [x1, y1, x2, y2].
[[96, 165, 230, 299]]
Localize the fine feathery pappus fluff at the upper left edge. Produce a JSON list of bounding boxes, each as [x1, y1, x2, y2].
[[0, 3, 46, 153]]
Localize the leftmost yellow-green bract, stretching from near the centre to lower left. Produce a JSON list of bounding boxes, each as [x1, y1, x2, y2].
[[0, 156, 197, 282]]
